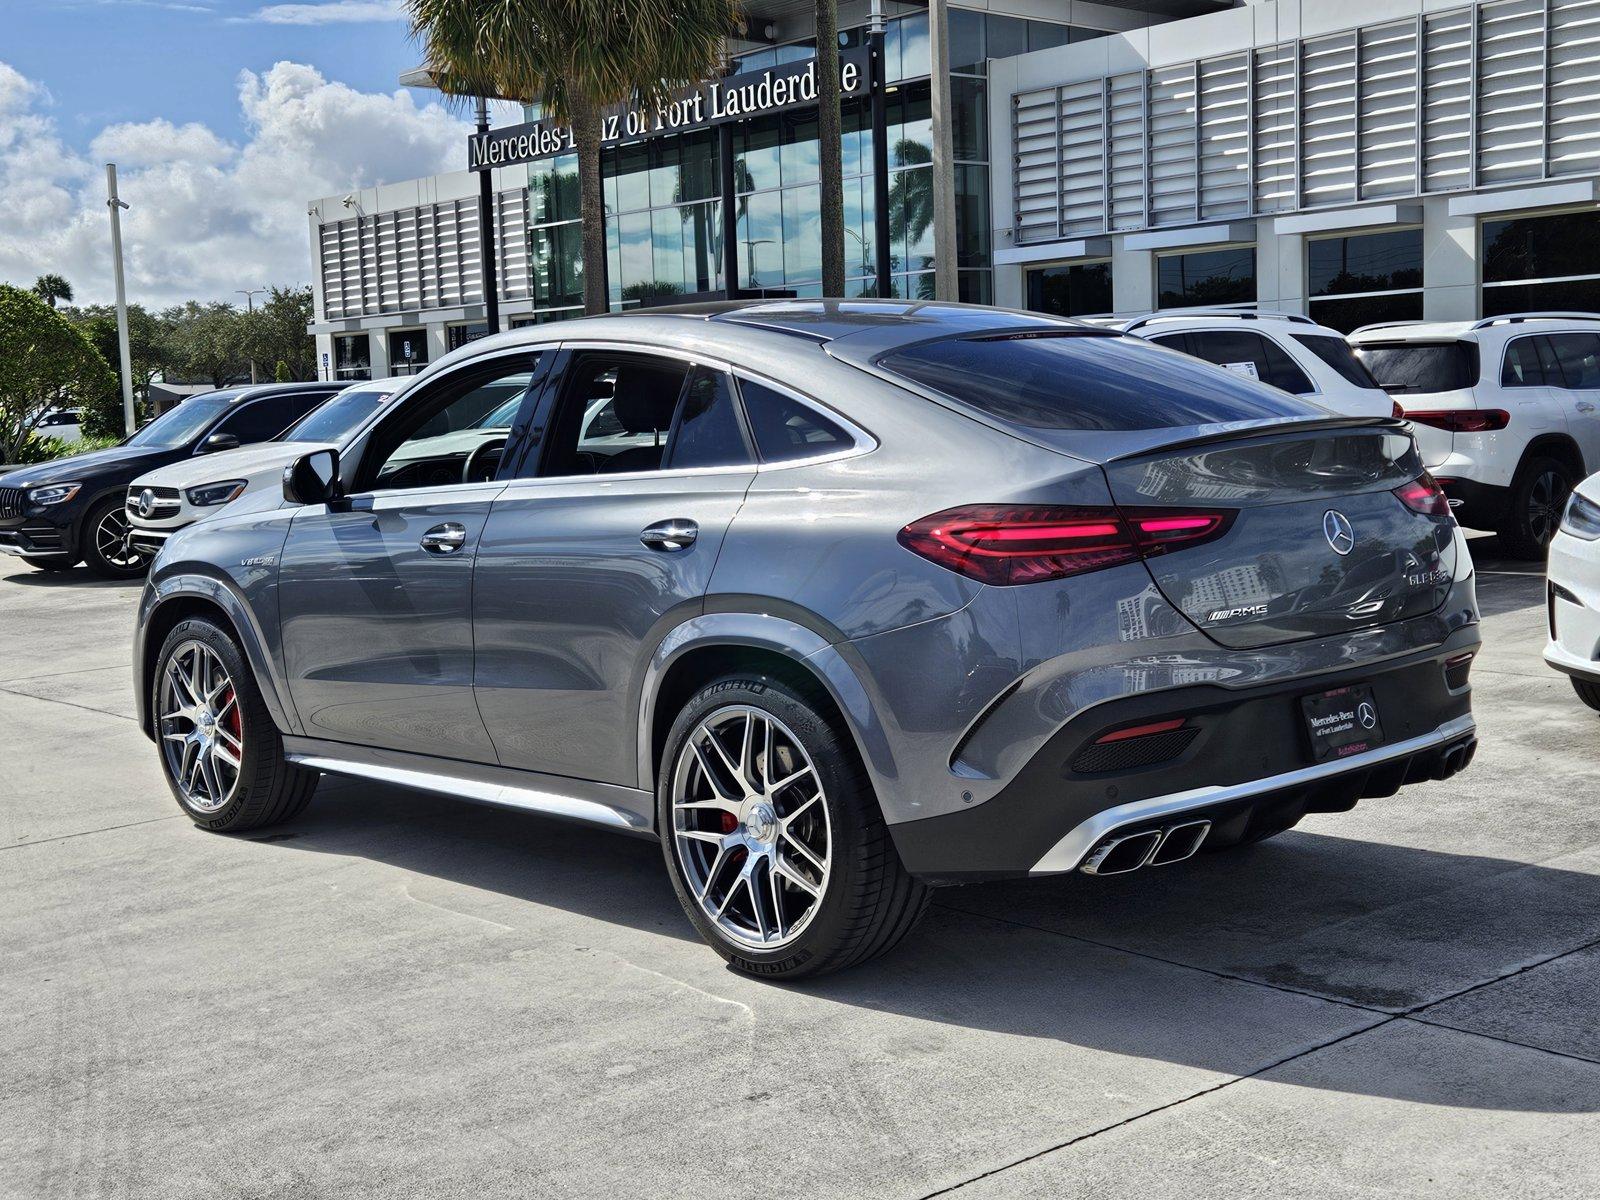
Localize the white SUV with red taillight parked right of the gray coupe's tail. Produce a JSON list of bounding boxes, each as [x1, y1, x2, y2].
[[1350, 312, 1600, 558]]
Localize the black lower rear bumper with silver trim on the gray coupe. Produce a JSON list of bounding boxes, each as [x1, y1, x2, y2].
[[890, 627, 1478, 882]]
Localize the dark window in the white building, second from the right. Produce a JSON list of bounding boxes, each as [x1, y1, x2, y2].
[[1306, 229, 1422, 333]]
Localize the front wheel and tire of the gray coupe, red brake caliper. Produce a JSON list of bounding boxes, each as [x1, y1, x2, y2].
[[150, 618, 317, 832]]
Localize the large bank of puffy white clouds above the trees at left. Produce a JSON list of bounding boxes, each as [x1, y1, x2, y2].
[[0, 62, 469, 307]]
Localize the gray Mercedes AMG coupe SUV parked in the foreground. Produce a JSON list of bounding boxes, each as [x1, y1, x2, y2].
[[134, 301, 1478, 978]]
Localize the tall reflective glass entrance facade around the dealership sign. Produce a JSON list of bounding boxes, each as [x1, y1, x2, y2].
[[505, 8, 1075, 322]]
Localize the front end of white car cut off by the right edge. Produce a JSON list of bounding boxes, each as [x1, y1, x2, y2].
[[1544, 475, 1600, 712]]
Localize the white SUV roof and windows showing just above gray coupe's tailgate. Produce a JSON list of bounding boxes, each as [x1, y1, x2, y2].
[[1096, 309, 1398, 416]]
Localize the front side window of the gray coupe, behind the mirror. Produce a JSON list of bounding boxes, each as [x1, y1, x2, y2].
[[358, 355, 536, 491]]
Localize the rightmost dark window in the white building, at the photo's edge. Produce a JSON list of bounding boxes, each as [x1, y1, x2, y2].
[[1482, 210, 1600, 317]]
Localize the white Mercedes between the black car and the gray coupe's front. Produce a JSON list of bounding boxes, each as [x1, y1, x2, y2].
[[126, 378, 410, 554]]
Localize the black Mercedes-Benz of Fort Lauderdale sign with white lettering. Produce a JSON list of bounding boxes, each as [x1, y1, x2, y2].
[[467, 48, 867, 171]]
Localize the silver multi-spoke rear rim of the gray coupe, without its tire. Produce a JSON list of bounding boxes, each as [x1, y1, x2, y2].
[[672, 704, 832, 950]]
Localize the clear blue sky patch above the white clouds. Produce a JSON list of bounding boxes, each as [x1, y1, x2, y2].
[[9, 0, 421, 147]]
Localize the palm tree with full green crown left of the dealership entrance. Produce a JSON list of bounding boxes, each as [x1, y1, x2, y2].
[[406, 0, 738, 314]]
